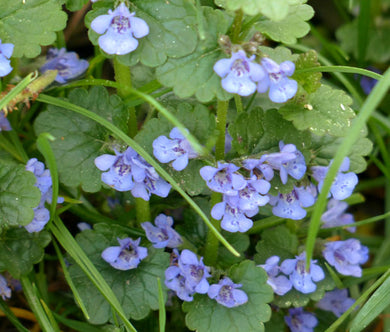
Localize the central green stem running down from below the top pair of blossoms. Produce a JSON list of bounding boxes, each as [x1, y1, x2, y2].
[[204, 100, 229, 265]]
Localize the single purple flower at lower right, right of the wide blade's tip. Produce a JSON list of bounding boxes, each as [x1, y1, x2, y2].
[[322, 239, 368, 277]]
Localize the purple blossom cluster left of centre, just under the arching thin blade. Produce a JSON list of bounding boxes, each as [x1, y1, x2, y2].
[[95, 147, 171, 201]]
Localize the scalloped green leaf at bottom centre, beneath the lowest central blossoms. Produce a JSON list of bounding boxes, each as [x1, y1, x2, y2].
[[183, 260, 272, 332]]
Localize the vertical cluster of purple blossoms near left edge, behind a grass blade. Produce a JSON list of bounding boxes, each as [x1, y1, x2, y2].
[[24, 158, 64, 233]]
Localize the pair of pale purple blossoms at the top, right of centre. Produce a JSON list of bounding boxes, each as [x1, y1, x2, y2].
[[214, 50, 298, 103]]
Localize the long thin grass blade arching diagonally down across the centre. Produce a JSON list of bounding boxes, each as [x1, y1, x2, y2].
[[37, 90, 240, 256]]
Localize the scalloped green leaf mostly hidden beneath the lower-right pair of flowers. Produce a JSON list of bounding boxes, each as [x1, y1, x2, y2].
[[273, 257, 335, 308]]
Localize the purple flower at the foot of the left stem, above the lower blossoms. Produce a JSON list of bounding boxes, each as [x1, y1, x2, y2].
[[141, 214, 183, 248]]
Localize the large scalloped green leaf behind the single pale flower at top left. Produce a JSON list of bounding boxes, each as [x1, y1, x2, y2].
[[85, 0, 198, 67]]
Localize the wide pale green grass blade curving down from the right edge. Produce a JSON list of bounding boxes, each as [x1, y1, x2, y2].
[[306, 69, 390, 267]]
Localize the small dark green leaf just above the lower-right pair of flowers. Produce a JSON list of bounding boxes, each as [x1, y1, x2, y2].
[[254, 226, 298, 264]]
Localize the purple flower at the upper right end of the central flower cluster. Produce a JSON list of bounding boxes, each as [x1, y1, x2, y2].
[[262, 141, 306, 184]]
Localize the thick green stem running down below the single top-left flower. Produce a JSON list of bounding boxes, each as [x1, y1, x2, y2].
[[114, 58, 151, 224]]
